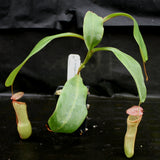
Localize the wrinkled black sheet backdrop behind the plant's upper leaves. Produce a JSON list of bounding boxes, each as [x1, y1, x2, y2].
[[0, 0, 160, 96]]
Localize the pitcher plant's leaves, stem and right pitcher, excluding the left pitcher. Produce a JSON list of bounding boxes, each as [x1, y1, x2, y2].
[[5, 11, 148, 158]]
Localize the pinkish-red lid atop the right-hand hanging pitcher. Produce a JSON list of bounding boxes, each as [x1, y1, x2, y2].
[[126, 106, 143, 116]]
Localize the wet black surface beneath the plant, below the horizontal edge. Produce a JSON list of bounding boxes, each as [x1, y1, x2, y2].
[[0, 96, 160, 160]]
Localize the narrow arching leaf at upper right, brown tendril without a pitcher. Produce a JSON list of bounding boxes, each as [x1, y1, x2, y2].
[[103, 13, 148, 62]]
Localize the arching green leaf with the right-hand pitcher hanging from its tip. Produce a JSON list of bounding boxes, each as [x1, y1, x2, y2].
[[93, 47, 147, 103]]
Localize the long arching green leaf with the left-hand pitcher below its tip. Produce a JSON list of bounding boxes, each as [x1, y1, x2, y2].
[[5, 32, 83, 87]]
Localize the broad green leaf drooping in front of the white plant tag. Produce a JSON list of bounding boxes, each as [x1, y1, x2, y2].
[[48, 75, 88, 133]]
